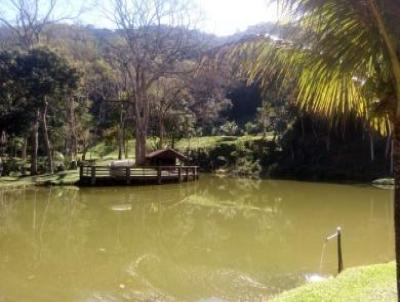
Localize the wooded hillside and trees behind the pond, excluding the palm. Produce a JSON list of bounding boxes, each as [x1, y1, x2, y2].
[[0, 1, 392, 180]]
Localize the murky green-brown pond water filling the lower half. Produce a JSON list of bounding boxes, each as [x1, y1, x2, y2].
[[0, 176, 394, 302]]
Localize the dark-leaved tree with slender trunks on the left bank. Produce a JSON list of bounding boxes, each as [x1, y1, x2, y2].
[[4, 48, 79, 175]]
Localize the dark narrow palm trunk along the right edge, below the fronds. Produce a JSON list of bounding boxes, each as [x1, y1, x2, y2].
[[393, 119, 400, 301]]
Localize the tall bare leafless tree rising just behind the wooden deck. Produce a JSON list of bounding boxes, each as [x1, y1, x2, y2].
[[108, 0, 198, 165]]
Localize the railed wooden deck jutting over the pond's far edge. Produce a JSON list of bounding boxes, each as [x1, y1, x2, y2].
[[79, 165, 199, 186]]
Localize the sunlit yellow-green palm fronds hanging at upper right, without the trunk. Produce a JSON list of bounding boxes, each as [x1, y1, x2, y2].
[[234, 0, 393, 132]]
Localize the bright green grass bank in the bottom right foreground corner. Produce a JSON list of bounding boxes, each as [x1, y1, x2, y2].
[[272, 263, 397, 302]]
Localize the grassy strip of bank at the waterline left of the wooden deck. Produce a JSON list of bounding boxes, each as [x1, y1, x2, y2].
[[0, 171, 79, 188]]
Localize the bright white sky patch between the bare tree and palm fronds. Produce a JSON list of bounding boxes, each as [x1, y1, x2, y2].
[[199, 0, 277, 35]]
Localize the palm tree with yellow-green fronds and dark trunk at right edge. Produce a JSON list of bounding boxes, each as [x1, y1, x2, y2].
[[240, 0, 400, 301]]
